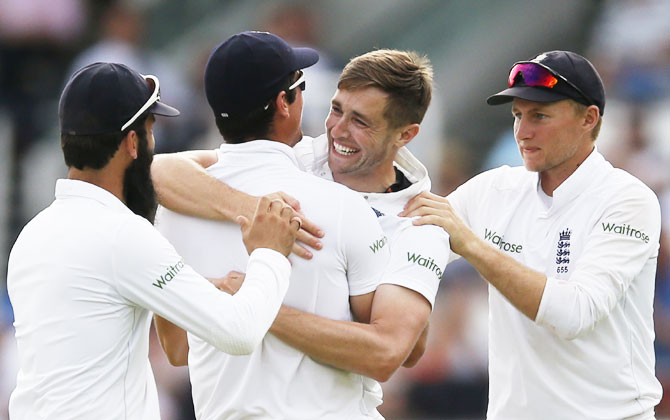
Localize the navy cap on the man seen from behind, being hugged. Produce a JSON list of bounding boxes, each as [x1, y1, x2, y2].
[[205, 31, 319, 117]]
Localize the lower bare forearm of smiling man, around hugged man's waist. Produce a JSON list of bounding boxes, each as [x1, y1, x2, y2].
[[270, 306, 416, 382]]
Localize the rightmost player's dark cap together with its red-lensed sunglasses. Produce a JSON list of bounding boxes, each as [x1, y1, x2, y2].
[[486, 51, 605, 115]]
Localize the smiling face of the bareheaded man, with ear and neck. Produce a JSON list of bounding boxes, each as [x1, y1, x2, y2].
[[326, 87, 402, 191]]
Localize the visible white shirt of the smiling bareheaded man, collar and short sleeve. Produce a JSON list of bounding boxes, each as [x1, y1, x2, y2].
[[293, 134, 451, 307]]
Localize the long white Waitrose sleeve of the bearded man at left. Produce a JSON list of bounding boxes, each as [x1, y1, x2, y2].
[[113, 217, 291, 354]]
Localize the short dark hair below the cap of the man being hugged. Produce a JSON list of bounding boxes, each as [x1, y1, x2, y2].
[[214, 72, 299, 144]]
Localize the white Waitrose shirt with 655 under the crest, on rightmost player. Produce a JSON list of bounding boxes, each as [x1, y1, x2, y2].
[[448, 151, 661, 420]]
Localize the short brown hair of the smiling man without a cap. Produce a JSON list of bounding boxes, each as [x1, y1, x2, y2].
[[337, 49, 433, 127]]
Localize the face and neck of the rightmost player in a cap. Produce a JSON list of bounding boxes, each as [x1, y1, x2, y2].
[[512, 98, 594, 193]]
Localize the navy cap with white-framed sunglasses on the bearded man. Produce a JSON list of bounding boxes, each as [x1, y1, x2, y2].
[[58, 63, 179, 135]]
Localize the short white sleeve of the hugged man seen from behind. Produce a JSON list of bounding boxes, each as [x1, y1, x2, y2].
[[340, 194, 390, 296]]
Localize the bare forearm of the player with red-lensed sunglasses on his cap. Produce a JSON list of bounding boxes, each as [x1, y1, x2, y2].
[[461, 234, 547, 320]]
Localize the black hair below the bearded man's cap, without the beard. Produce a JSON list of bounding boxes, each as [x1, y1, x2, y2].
[[60, 113, 149, 170]]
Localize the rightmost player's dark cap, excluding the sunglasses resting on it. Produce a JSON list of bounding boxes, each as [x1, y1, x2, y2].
[[486, 51, 605, 115]]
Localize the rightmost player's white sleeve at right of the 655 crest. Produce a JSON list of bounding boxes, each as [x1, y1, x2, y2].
[[535, 187, 661, 339]]
